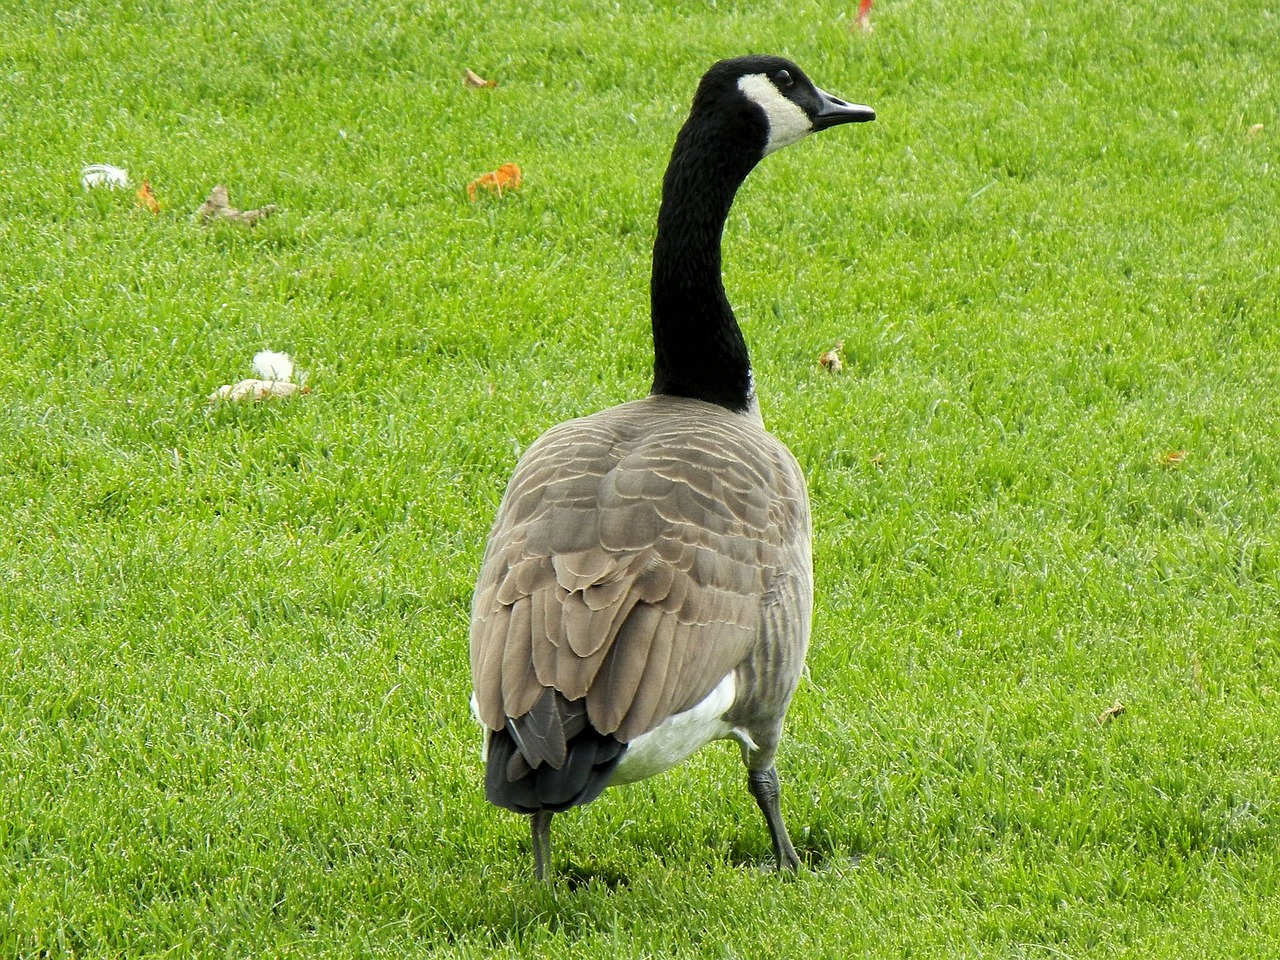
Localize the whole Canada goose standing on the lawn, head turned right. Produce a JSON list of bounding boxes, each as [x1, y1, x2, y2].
[[471, 56, 876, 879]]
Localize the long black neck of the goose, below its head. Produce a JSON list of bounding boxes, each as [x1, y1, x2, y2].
[[649, 106, 762, 411]]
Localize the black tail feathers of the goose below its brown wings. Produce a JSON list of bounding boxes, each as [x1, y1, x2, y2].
[[484, 691, 626, 813]]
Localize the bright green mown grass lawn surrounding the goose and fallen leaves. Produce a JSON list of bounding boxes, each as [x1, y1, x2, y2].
[[0, 0, 1280, 960]]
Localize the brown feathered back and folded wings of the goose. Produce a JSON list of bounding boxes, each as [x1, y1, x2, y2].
[[471, 398, 808, 742]]
